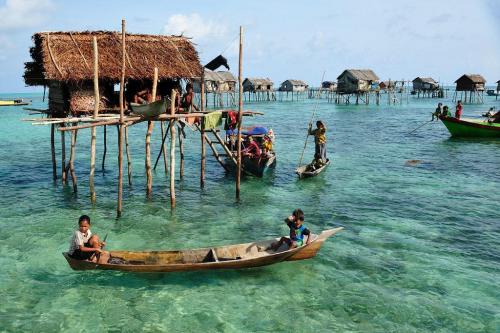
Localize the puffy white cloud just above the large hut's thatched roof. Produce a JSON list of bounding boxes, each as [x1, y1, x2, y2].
[[163, 13, 227, 42]]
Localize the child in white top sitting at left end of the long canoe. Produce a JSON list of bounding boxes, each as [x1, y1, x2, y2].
[[68, 215, 106, 260]]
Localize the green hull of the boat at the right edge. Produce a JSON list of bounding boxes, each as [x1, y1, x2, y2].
[[440, 117, 500, 138]]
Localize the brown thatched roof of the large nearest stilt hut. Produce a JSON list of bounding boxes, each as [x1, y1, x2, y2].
[[24, 31, 201, 85]]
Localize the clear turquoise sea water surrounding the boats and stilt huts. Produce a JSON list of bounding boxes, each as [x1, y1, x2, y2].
[[0, 91, 500, 332]]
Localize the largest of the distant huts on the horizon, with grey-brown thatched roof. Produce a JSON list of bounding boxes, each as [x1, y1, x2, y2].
[[337, 69, 379, 94]]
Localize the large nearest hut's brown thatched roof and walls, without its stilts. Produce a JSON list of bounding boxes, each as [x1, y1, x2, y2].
[[24, 31, 201, 113]]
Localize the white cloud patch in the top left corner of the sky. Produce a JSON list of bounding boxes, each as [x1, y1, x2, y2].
[[0, 0, 54, 31]]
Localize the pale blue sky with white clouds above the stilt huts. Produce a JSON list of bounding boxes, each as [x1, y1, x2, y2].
[[0, 0, 500, 93]]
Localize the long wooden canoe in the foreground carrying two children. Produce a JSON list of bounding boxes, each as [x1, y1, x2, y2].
[[63, 227, 343, 272]]
